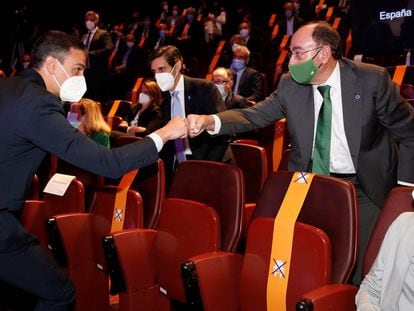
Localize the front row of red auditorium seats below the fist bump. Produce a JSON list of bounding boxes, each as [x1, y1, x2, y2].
[[24, 147, 412, 310]]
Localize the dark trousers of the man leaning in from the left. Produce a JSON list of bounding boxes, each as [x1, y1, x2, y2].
[[0, 211, 75, 311]]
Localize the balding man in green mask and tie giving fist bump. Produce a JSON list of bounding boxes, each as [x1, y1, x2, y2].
[[186, 22, 414, 284]]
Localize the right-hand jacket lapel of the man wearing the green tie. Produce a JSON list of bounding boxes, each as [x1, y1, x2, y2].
[[339, 61, 362, 167]]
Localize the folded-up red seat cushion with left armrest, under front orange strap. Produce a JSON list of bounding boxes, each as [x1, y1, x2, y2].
[[183, 218, 331, 311]]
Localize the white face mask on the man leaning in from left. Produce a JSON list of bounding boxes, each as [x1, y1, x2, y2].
[[52, 59, 86, 102]]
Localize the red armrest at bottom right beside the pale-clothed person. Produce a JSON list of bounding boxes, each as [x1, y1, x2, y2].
[[296, 284, 358, 311]]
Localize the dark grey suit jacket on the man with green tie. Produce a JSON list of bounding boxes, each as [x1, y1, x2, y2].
[[219, 59, 414, 207]]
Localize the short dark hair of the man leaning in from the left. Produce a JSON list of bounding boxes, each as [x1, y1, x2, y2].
[[30, 30, 87, 69]]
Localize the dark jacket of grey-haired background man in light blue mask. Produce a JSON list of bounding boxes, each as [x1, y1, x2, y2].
[[234, 67, 265, 102]]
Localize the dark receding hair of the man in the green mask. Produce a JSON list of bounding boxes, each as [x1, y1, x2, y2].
[[312, 21, 343, 59]]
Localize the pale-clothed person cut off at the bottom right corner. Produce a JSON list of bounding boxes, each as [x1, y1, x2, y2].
[[355, 191, 414, 311]]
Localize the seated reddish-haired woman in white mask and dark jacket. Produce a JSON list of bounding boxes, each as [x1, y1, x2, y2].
[[120, 80, 162, 137]]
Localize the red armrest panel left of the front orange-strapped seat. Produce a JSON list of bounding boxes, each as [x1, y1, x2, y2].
[[183, 252, 243, 311]]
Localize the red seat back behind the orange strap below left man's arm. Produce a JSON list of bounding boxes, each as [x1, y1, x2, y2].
[[92, 186, 144, 229]]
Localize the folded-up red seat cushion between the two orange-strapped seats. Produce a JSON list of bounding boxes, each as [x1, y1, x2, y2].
[[155, 198, 220, 303]]
